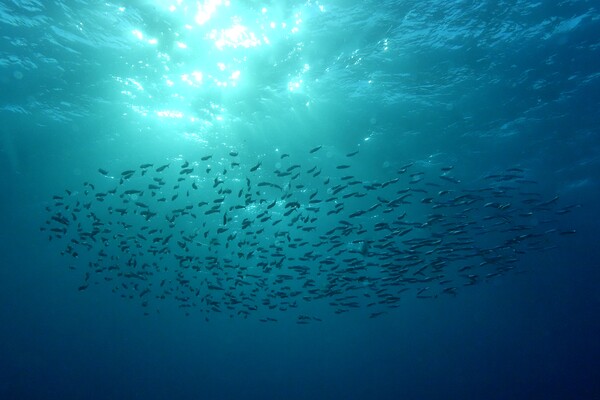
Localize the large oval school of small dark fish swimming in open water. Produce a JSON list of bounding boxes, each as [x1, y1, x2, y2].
[[40, 146, 578, 324]]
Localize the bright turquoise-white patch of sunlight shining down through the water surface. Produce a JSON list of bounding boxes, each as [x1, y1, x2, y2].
[[114, 0, 318, 138]]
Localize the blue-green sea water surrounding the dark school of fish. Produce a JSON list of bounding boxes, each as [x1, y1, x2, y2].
[[0, 0, 600, 399]]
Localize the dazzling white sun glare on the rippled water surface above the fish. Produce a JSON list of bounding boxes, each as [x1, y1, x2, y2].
[[117, 0, 323, 130]]
